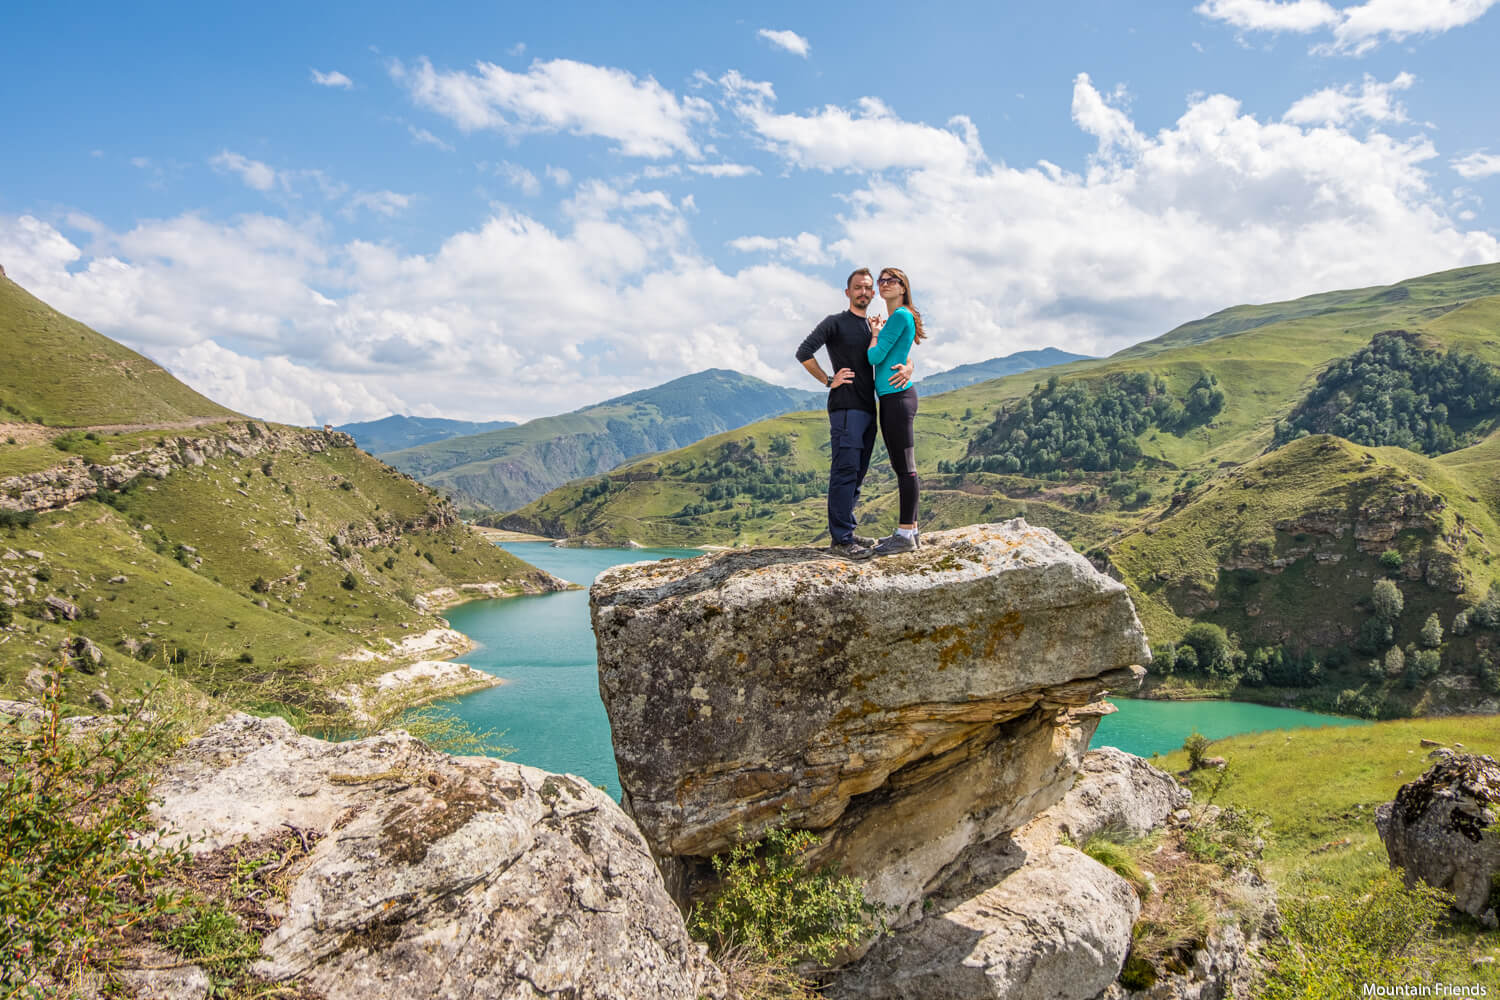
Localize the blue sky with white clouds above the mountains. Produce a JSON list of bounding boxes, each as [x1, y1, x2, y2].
[[0, 0, 1500, 423]]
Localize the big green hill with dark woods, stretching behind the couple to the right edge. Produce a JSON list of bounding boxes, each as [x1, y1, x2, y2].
[[497, 265, 1500, 715]]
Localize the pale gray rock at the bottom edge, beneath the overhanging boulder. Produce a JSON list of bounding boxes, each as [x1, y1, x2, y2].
[[827, 846, 1140, 1000]]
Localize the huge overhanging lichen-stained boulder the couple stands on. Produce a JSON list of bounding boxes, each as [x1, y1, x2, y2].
[[590, 520, 1151, 924]]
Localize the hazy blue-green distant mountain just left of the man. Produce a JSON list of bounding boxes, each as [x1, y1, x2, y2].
[[381, 369, 824, 510]]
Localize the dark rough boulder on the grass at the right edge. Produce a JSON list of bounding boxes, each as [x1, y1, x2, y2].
[[1376, 753, 1500, 927]]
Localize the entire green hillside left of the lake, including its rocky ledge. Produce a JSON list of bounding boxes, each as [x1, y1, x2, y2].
[[0, 282, 555, 721]]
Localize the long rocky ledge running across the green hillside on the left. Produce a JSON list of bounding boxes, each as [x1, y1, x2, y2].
[[0, 420, 357, 517]]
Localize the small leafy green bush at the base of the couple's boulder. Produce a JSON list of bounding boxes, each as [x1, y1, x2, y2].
[[687, 828, 875, 966]]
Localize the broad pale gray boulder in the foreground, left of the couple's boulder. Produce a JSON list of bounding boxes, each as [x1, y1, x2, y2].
[[156, 715, 723, 1000]]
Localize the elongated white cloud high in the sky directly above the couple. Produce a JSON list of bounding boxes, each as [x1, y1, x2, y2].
[[719, 70, 983, 171]]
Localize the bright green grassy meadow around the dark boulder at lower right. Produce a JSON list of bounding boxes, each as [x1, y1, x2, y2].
[[1160, 715, 1500, 996]]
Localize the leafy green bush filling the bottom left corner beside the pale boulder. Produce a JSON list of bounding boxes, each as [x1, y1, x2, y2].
[[0, 664, 186, 997]]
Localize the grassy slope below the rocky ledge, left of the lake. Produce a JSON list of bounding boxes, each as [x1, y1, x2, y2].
[[0, 448, 552, 709]]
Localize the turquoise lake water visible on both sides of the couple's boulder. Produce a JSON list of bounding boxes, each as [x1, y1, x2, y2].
[[447, 541, 1364, 799]]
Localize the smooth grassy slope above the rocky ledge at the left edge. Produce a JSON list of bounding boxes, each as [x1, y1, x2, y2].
[[0, 277, 236, 426]]
